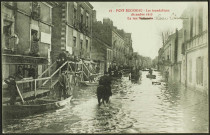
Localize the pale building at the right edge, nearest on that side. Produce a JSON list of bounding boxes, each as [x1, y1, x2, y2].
[[181, 2, 209, 93]]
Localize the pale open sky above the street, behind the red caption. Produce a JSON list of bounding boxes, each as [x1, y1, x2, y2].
[[90, 2, 190, 59]]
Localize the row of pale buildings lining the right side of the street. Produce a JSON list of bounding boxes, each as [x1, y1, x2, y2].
[[158, 2, 209, 93]]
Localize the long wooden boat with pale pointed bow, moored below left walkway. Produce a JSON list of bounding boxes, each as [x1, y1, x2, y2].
[[2, 96, 72, 118]]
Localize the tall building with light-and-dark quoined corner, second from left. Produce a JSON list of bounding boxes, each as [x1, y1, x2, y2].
[[52, 2, 93, 61]]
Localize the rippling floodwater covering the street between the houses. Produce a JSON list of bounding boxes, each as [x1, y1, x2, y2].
[[3, 72, 209, 133]]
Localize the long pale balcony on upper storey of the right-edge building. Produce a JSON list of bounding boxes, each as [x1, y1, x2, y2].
[[185, 31, 208, 51]]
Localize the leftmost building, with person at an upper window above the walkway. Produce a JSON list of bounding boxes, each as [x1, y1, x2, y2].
[[1, 2, 56, 79]]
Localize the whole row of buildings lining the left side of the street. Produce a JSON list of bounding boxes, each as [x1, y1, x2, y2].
[[1, 2, 136, 79]]
